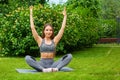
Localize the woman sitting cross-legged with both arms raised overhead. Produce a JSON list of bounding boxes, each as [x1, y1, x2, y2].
[[25, 6, 72, 72]]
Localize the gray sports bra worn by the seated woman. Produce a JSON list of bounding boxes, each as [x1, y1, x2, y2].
[[40, 39, 55, 52]]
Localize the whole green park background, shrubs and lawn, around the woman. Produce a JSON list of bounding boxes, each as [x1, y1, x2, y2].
[[0, 0, 120, 80]]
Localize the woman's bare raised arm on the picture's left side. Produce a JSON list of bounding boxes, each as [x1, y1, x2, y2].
[[30, 6, 42, 46]]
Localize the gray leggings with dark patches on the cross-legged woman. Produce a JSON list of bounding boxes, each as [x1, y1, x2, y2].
[[25, 54, 72, 71]]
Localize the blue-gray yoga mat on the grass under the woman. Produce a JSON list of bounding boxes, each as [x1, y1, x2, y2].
[[16, 67, 73, 73]]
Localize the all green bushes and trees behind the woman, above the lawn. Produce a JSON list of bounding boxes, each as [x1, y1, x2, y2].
[[0, 0, 120, 56]]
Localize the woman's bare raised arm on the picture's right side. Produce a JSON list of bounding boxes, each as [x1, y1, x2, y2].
[[54, 8, 67, 45]]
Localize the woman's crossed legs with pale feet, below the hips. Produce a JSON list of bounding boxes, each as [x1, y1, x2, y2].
[[25, 54, 72, 72]]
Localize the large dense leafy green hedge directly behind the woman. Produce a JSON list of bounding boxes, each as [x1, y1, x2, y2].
[[0, 0, 99, 55]]
